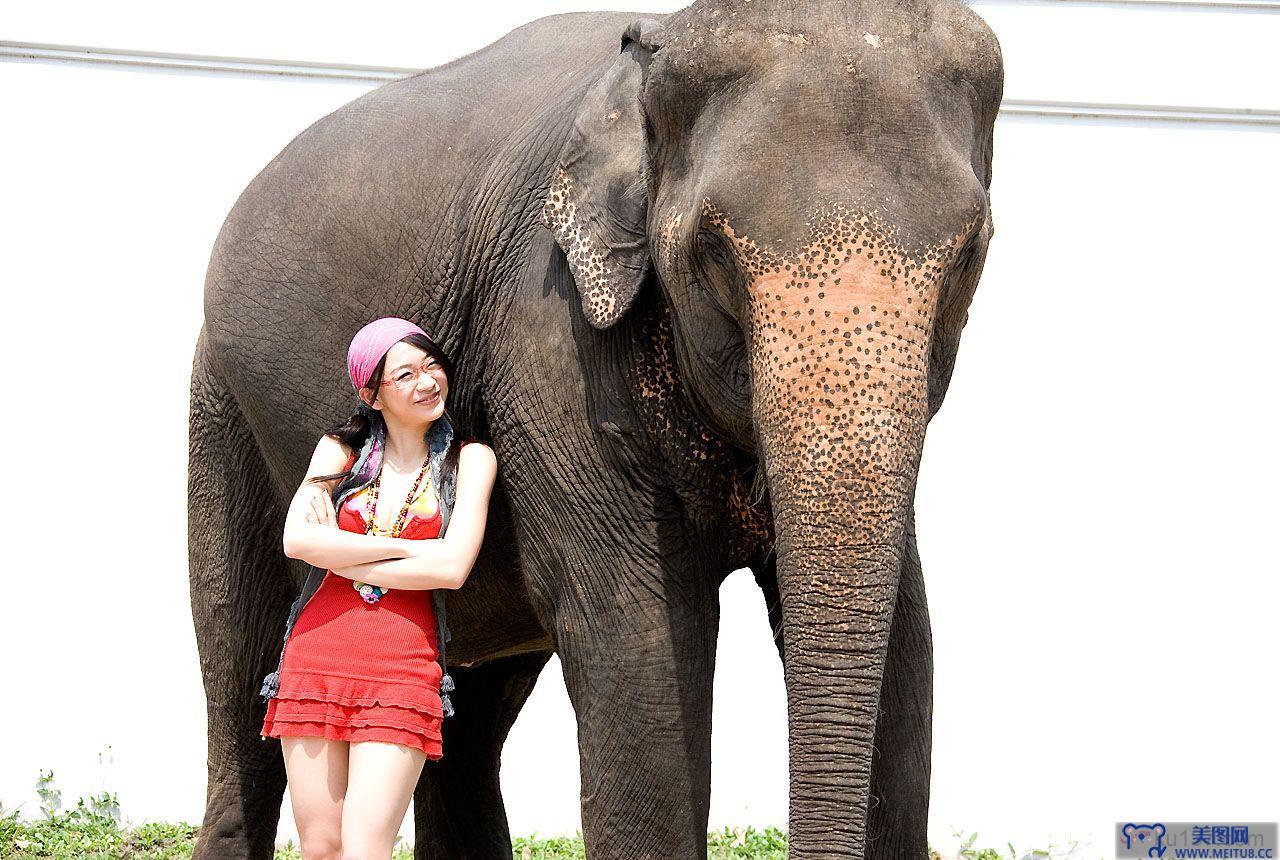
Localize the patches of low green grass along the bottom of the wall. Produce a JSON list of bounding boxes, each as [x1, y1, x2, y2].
[[0, 772, 1100, 860]]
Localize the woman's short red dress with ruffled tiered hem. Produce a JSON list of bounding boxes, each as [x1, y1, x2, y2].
[[262, 450, 460, 760]]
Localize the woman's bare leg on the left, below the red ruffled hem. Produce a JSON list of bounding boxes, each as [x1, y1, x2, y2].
[[280, 737, 351, 860]]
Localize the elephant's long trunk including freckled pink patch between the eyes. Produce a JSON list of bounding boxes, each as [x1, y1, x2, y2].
[[704, 201, 980, 857]]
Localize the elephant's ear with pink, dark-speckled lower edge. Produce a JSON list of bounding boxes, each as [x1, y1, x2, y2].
[[541, 18, 662, 329]]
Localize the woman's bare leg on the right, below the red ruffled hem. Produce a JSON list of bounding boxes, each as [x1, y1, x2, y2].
[[342, 741, 426, 860]]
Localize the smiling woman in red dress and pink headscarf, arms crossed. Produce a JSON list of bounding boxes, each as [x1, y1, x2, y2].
[[262, 317, 497, 860]]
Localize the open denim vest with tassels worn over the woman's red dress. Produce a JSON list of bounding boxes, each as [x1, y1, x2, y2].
[[259, 410, 457, 717]]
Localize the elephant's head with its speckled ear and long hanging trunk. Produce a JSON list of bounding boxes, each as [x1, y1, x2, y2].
[[543, 0, 1004, 856]]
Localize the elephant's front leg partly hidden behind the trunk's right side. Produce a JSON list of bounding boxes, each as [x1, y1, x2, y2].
[[867, 512, 933, 860]]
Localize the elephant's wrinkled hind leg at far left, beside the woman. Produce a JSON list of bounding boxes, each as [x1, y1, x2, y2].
[[186, 331, 294, 860]]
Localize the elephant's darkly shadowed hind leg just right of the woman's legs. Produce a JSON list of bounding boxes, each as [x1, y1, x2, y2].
[[413, 651, 552, 860]]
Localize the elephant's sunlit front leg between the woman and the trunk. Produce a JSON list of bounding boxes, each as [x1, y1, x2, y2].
[[535, 531, 719, 860]]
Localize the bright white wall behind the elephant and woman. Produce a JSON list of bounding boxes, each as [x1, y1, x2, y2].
[[0, 0, 1280, 856]]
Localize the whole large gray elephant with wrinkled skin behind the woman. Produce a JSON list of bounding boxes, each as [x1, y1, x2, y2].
[[189, 0, 1002, 860]]
